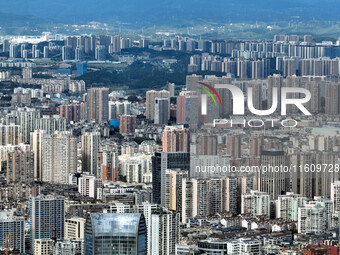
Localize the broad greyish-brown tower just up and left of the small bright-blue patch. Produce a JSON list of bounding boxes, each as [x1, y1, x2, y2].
[[87, 88, 109, 123]]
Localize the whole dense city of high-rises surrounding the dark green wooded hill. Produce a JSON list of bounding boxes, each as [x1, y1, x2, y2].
[[0, 32, 340, 255]]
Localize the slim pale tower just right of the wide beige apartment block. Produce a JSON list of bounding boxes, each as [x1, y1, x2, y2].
[[81, 131, 100, 175]]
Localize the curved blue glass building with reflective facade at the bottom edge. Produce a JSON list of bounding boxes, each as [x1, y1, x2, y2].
[[85, 213, 147, 255]]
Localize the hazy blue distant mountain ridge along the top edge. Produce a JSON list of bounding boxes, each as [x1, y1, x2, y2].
[[0, 0, 340, 25]]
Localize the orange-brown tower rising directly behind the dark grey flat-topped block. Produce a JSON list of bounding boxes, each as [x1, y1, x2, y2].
[[162, 125, 190, 152]]
